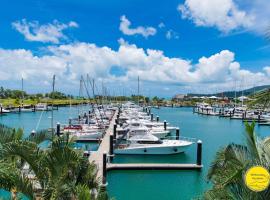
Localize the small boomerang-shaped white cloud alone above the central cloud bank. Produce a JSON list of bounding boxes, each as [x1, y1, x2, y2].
[[119, 15, 157, 38]]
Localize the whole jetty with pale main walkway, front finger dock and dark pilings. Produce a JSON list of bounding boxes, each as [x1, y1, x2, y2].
[[89, 105, 203, 187]]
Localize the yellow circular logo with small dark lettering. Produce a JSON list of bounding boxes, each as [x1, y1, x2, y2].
[[245, 166, 270, 192]]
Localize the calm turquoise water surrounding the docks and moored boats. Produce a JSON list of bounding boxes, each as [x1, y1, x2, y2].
[[0, 107, 270, 200]]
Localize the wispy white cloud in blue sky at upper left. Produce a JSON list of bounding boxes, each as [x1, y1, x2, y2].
[[12, 19, 78, 44]]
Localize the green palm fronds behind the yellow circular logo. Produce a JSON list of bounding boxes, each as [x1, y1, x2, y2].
[[204, 122, 270, 200]]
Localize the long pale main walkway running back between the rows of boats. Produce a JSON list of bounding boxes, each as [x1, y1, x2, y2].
[[89, 110, 118, 179]]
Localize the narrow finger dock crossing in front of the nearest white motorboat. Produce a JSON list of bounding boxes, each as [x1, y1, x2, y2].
[[107, 163, 203, 171]]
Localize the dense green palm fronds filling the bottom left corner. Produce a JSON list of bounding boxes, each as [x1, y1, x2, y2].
[[0, 126, 107, 200]]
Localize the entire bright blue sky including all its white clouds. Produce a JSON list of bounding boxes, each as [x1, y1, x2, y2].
[[0, 0, 270, 96]]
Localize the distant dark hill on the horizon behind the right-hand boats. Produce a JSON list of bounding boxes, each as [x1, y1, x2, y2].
[[188, 85, 270, 98]]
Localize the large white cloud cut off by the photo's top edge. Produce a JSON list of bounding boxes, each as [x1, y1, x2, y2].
[[177, 0, 255, 33]]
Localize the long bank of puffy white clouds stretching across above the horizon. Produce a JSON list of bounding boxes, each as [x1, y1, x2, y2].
[[0, 39, 270, 92]]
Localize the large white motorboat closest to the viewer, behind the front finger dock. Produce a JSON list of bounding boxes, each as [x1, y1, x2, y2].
[[114, 134, 193, 155]]
